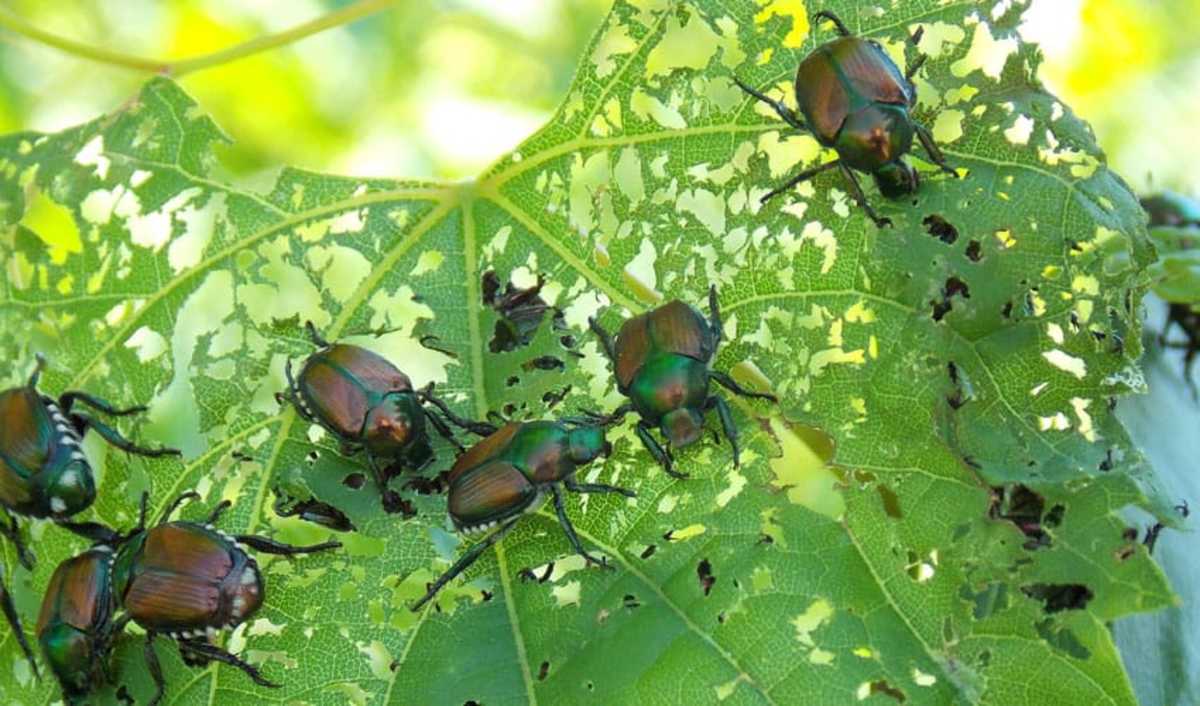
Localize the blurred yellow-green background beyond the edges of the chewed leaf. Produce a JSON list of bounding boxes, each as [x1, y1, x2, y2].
[[0, 0, 1200, 704]]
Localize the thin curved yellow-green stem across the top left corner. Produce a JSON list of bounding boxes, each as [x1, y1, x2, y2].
[[0, 0, 397, 77]]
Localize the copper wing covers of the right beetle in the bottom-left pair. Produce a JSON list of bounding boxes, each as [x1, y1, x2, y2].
[[122, 522, 233, 630]]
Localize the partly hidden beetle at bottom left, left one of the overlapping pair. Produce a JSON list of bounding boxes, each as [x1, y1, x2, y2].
[[37, 544, 128, 704]]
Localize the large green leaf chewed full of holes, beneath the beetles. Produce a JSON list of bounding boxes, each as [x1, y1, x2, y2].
[[0, 0, 1175, 706]]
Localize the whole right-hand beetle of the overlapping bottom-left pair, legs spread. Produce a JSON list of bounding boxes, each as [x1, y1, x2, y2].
[[112, 492, 341, 706]]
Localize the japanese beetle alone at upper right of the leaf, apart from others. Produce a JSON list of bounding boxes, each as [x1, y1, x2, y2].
[[734, 11, 958, 227]]
